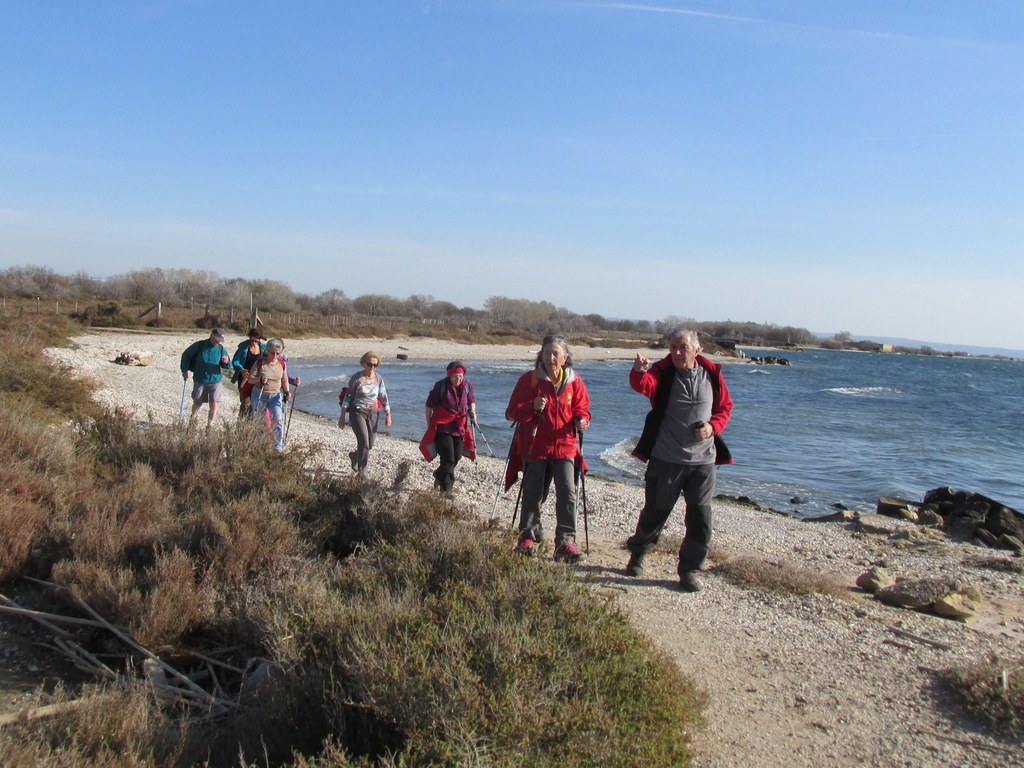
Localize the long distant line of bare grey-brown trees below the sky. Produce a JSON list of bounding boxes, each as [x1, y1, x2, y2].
[[0, 266, 818, 346]]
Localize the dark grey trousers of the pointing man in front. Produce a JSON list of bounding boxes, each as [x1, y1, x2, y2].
[[626, 459, 715, 575]]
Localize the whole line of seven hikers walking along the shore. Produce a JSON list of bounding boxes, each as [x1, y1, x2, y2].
[[181, 329, 732, 592]]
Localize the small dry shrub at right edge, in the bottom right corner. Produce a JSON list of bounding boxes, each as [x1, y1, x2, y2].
[[942, 656, 1024, 743]]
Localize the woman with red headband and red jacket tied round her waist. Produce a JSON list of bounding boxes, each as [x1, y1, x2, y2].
[[420, 360, 476, 493]]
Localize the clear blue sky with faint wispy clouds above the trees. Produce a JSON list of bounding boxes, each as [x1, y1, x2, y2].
[[0, 0, 1024, 349]]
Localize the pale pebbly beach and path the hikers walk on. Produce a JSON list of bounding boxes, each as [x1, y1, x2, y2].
[[25, 333, 1024, 768]]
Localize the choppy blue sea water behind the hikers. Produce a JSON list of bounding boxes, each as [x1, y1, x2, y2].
[[291, 349, 1024, 516]]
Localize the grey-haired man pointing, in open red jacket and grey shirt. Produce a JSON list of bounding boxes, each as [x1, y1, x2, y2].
[[626, 330, 732, 592]]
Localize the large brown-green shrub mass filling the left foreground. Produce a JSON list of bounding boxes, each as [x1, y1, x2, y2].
[[0, 317, 703, 768]]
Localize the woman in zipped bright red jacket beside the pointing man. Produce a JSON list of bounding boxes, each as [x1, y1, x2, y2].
[[505, 336, 590, 563]]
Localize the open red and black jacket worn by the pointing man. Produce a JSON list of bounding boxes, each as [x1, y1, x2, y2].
[[630, 354, 732, 464]]
